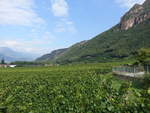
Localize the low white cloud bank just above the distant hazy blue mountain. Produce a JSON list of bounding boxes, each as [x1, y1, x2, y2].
[[0, 31, 56, 55]]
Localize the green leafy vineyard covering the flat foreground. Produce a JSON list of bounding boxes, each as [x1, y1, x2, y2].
[[0, 64, 150, 113]]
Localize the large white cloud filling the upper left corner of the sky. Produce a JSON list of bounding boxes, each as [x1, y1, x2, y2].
[[0, 0, 44, 26]]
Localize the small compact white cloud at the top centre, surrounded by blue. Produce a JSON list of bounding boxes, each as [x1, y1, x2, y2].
[[51, 0, 69, 17]]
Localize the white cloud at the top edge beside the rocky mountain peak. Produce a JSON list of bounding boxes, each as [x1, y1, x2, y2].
[[115, 0, 145, 8]]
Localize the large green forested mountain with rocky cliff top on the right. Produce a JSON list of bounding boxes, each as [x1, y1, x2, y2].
[[36, 0, 150, 63]]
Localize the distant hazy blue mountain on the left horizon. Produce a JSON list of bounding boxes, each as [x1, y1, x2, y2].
[[0, 47, 33, 62]]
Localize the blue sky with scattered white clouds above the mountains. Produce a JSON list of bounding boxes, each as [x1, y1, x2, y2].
[[0, 0, 144, 55]]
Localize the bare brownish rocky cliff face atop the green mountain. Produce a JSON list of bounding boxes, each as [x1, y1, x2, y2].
[[120, 0, 150, 30]]
